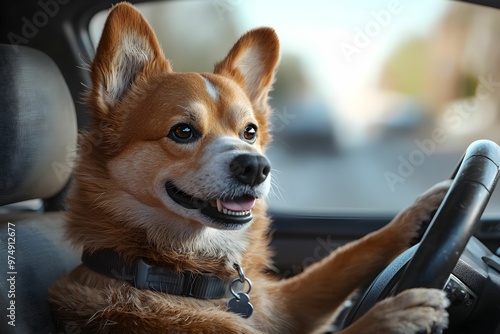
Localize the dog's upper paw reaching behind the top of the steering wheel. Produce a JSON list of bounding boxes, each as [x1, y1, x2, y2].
[[391, 180, 452, 247]]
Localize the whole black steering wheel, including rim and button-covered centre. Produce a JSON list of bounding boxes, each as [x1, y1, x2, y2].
[[340, 140, 500, 333]]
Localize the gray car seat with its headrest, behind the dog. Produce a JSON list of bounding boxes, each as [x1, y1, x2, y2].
[[0, 45, 81, 334]]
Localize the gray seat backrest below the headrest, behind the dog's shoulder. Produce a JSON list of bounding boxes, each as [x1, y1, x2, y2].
[[0, 213, 80, 334]]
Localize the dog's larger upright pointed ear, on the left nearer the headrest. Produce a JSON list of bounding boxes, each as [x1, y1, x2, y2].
[[89, 3, 171, 114]]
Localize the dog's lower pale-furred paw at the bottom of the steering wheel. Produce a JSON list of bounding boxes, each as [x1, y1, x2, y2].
[[354, 288, 450, 334]]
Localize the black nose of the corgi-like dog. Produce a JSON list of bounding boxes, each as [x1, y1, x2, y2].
[[229, 154, 271, 187]]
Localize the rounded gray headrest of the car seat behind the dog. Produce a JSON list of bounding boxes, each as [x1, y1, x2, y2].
[[0, 44, 77, 205]]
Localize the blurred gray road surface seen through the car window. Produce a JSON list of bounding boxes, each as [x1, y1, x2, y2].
[[268, 136, 500, 214]]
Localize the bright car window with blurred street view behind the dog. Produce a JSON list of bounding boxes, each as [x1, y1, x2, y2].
[[90, 0, 500, 214]]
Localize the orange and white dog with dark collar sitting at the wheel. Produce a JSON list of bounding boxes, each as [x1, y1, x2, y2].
[[49, 3, 449, 334]]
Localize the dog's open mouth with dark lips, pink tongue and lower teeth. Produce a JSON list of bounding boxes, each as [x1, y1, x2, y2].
[[165, 182, 256, 227]]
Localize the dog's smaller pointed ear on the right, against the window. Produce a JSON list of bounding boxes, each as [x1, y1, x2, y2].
[[214, 28, 279, 112]]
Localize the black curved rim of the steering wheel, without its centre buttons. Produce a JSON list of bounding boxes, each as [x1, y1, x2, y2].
[[341, 140, 500, 329]]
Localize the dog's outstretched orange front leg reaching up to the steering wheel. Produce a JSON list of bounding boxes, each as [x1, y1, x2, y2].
[[275, 181, 451, 333]]
